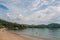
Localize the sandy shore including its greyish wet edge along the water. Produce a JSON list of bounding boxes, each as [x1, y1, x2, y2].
[[0, 28, 55, 40]]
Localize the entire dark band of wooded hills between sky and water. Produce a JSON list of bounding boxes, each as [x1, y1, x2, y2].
[[0, 19, 60, 30]]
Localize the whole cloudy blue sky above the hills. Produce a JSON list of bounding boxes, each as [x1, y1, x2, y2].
[[0, 0, 60, 24]]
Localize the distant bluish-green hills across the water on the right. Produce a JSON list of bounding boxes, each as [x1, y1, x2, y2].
[[29, 23, 60, 28]]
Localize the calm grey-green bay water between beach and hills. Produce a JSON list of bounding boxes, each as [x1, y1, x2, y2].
[[15, 28, 60, 40]]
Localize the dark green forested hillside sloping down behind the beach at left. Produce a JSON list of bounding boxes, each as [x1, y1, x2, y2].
[[0, 19, 26, 30]]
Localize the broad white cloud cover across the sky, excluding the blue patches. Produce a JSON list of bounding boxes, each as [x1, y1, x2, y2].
[[2, 0, 60, 24]]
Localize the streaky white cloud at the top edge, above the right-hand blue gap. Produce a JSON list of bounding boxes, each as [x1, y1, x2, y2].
[[29, 0, 55, 11]]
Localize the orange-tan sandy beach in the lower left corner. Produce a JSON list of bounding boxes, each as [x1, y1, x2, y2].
[[0, 29, 43, 40]]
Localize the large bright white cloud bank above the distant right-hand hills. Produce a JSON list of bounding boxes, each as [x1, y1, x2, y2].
[[23, 6, 60, 24]]
